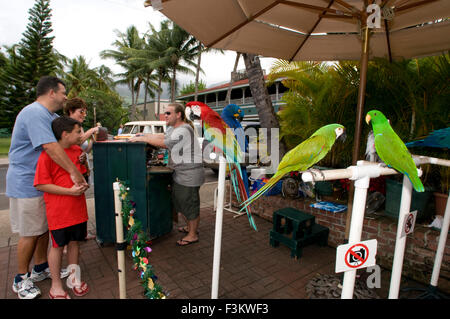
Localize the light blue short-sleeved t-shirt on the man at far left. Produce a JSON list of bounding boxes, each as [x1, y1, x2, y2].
[[6, 102, 58, 198]]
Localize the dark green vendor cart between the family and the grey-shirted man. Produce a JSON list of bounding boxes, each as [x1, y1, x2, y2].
[[93, 141, 173, 243]]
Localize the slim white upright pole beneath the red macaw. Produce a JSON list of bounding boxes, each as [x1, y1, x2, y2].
[[211, 156, 226, 299]]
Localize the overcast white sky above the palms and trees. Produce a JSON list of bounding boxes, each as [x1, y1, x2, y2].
[[0, 0, 274, 86]]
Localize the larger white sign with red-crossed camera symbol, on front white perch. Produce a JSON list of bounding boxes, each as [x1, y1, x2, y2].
[[336, 239, 377, 273]]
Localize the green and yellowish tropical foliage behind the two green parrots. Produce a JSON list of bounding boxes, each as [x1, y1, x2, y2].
[[269, 54, 450, 167]]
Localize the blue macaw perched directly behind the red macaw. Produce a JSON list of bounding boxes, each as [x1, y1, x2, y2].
[[220, 104, 250, 197]]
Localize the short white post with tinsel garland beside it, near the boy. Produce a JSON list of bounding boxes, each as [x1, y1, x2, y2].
[[113, 182, 127, 299]]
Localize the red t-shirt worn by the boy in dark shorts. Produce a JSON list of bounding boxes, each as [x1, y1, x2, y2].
[[34, 145, 88, 230]]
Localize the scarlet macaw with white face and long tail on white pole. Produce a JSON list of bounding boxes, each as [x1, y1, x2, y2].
[[186, 101, 257, 230]]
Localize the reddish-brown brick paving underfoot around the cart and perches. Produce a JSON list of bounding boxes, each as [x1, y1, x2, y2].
[[0, 191, 428, 299]]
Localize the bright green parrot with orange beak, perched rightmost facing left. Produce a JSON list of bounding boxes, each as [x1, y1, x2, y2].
[[366, 110, 425, 192]]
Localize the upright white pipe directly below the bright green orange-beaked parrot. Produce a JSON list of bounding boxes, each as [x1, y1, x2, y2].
[[389, 175, 412, 299]]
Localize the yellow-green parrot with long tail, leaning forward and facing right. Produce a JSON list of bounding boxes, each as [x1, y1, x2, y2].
[[241, 124, 346, 210]]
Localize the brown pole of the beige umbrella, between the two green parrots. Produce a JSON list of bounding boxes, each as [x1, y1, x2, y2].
[[345, 25, 370, 242]]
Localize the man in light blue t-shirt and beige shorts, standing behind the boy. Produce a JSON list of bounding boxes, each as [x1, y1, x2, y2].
[[6, 76, 88, 299]]
